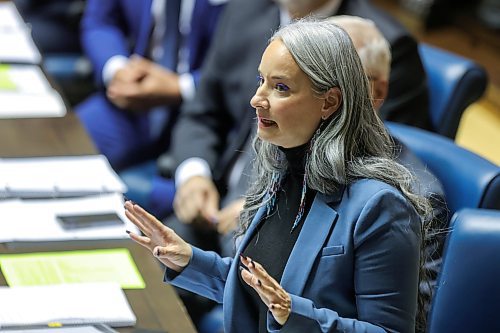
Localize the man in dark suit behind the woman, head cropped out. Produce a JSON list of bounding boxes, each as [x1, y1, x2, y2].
[[167, 0, 428, 246]]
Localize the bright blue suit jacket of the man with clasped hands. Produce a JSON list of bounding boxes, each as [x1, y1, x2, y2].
[[81, 0, 227, 85]]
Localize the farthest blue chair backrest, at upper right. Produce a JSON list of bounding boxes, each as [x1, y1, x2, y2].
[[419, 44, 488, 139]]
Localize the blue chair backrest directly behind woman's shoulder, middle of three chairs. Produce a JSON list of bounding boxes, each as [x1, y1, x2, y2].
[[386, 122, 500, 214]]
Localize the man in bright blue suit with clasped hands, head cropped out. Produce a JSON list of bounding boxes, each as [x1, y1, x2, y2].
[[76, 0, 227, 170]]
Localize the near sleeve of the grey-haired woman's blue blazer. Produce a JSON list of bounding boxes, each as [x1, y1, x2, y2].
[[267, 190, 421, 333]]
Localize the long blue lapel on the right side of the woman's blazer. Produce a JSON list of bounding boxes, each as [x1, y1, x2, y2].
[[280, 191, 342, 295]]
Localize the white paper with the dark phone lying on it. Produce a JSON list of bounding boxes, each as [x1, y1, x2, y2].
[[0, 194, 138, 243]]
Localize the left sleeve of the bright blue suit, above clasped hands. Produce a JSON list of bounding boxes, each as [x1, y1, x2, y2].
[[81, 0, 130, 85]]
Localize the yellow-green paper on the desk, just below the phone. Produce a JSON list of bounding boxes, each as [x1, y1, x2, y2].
[[0, 249, 146, 289]]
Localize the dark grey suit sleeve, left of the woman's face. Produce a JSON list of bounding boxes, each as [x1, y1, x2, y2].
[[171, 4, 233, 171]]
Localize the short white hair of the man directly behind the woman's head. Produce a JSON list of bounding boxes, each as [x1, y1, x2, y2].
[[327, 15, 392, 81]]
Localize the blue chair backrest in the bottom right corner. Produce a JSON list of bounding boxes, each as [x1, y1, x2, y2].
[[427, 209, 500, 333]]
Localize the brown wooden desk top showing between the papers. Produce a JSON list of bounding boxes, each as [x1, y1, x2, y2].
[[0, 112, 196, 333]]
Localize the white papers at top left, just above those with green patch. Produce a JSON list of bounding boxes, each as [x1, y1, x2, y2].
[[0, 28, 42, 64]]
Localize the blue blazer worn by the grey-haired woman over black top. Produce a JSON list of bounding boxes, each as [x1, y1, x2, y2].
[[164, 179, 421, 333]]
